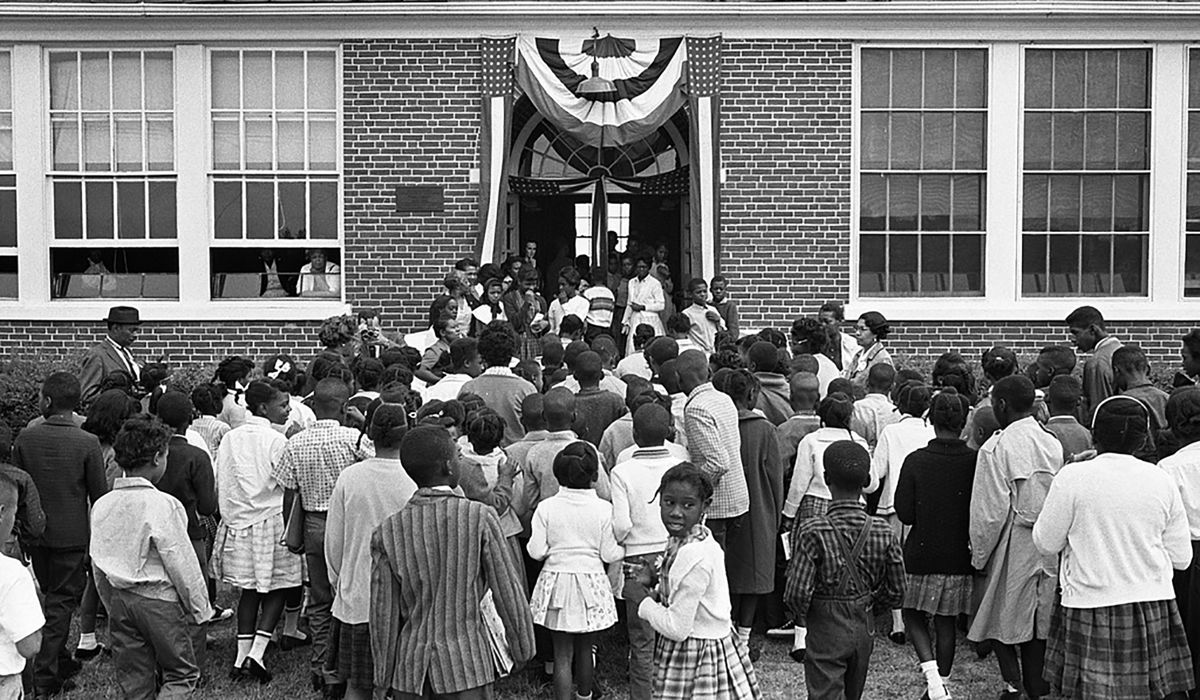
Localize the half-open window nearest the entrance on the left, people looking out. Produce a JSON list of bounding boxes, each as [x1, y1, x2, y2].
[[210, 50, 341, 298]]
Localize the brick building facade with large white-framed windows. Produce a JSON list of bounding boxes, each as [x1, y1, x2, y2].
[[0, 0, 1200, 372]]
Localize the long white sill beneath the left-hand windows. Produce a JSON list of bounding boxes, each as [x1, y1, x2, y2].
[[0, 299, 350, 323]]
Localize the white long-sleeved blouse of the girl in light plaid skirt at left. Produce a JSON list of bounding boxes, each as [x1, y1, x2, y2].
[[215, 415, 288, 530]]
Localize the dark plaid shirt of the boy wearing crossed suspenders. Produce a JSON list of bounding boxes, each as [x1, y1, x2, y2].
[[784, 501, 905, 627]]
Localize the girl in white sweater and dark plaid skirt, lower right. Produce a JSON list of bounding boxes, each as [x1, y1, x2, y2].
[[1033, 395, 1194, 700]]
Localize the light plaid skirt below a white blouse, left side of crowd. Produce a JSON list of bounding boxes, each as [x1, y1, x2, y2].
[[212, 515, 304, 593]]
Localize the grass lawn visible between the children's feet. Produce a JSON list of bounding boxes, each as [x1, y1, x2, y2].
[[61, 600, 1017, 700]]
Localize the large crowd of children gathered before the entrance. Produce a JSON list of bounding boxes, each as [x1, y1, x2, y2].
[[0, 259, 1200, 700]]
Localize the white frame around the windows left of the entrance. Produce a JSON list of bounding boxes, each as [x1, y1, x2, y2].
[[0, 41, 349, 323]]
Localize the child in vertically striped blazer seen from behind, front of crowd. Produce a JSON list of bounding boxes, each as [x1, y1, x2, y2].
[[367, 425, 533, 698]]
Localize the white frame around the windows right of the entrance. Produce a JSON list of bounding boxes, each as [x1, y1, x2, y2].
[[847, 40, 1200, 322]]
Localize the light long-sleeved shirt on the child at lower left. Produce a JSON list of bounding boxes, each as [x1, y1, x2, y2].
[[90, 477, 212, 622]]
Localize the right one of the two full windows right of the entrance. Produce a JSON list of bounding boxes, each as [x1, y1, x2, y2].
[[1021, 49, 1151, 297]]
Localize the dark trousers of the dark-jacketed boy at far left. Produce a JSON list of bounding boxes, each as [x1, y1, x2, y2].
[[29, 546, 88, 690]]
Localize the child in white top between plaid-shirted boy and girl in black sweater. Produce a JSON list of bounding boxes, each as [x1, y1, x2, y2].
[[870, 382, 936, 645]]
